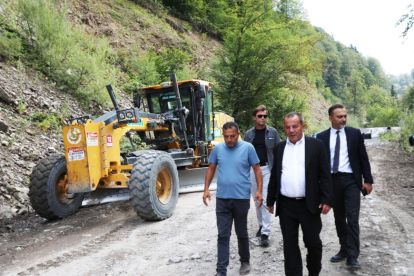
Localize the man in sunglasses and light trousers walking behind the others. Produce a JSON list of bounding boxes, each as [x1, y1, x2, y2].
[[244, 105, 280, 247]]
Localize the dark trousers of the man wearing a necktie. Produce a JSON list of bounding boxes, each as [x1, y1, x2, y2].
[[332, 174, 361, 259]]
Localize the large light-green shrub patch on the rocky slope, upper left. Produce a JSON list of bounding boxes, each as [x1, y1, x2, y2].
[[18, 0, 115, 103]]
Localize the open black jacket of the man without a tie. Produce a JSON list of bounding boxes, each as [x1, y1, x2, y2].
[[266, 137, 332, 216]]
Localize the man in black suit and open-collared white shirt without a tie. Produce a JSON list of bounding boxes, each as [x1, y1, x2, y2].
[[267, 112, 332, 276]]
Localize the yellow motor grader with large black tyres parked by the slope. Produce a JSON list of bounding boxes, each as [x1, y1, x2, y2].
[[29, 74, 232, 220]]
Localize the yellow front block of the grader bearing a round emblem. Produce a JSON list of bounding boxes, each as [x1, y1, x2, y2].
[[63, 122, 105, 193]]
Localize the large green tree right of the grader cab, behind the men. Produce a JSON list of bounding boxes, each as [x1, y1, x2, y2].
[[216, 0, 317, 128]]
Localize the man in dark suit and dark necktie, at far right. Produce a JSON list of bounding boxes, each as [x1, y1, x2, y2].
[[317, 104, 374, 268]]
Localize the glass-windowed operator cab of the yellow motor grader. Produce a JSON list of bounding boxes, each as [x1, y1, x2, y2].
[[134, 77, 215, 167]]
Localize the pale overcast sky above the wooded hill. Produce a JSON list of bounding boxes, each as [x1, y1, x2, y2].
[[302, 0, 414, 75]]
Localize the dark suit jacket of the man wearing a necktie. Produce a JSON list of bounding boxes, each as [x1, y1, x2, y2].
[[316, 127, 374, 188]]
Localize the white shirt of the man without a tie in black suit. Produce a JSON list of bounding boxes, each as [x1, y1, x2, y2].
[[280, 135, 306, 197]]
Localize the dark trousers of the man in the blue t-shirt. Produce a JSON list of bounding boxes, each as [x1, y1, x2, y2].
[[216, 198, 250, 274]]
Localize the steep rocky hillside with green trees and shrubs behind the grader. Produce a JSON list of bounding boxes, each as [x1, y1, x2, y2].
[[0, 0, 414, 218]]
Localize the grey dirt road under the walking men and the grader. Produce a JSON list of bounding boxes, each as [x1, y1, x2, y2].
[[0, 140, 414, 276]]
